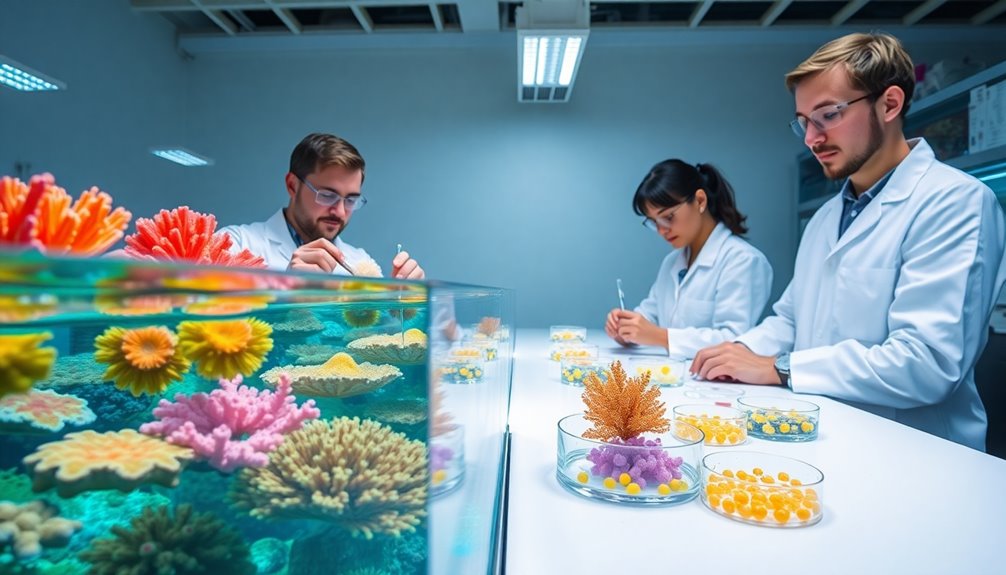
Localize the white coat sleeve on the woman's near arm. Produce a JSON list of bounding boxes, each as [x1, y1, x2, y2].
[[667, 251, 773, 358]]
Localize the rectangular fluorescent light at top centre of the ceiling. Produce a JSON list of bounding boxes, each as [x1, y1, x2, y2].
[[516, 0, 591, 103]]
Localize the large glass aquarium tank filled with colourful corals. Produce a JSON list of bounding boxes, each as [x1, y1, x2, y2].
[[0, 251, 513, 575]]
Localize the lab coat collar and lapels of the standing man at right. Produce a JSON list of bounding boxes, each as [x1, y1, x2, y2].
[[824, 138, 936, 257]]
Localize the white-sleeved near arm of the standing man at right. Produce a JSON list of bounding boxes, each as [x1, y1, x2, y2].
[[790, 180, 1004, 409]]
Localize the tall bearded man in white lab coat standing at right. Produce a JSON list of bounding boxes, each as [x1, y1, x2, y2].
[[691, 34, 1006, 450]]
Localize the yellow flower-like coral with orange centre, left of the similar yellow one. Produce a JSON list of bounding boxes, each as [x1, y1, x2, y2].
[[95, 327, 189, 396]]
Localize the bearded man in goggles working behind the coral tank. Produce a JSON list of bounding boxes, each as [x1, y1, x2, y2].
[[220, 134, 425, 279]]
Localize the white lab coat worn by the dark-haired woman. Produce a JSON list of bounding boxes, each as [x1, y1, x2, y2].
[[636, 223, 772, 359]]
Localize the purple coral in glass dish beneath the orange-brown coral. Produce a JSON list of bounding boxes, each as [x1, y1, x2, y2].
[[586, 436, 683, 489]]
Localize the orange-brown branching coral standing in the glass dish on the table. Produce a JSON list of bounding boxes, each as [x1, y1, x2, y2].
[[582, 361, 670, 441]]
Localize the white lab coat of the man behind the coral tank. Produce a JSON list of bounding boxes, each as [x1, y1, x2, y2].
[[220, 209, 380, 275]]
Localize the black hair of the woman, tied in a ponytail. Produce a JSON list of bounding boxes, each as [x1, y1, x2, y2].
[[633, 160, 747, 235]]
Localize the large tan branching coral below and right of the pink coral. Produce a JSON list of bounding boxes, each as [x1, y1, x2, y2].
[[230, 417, 428, 539]]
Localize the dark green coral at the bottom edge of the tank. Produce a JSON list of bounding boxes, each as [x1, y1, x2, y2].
[[79, 505, 256, 575]]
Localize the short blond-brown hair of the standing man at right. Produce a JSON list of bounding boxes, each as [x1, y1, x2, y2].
[[786, 32, 915, 118]]
